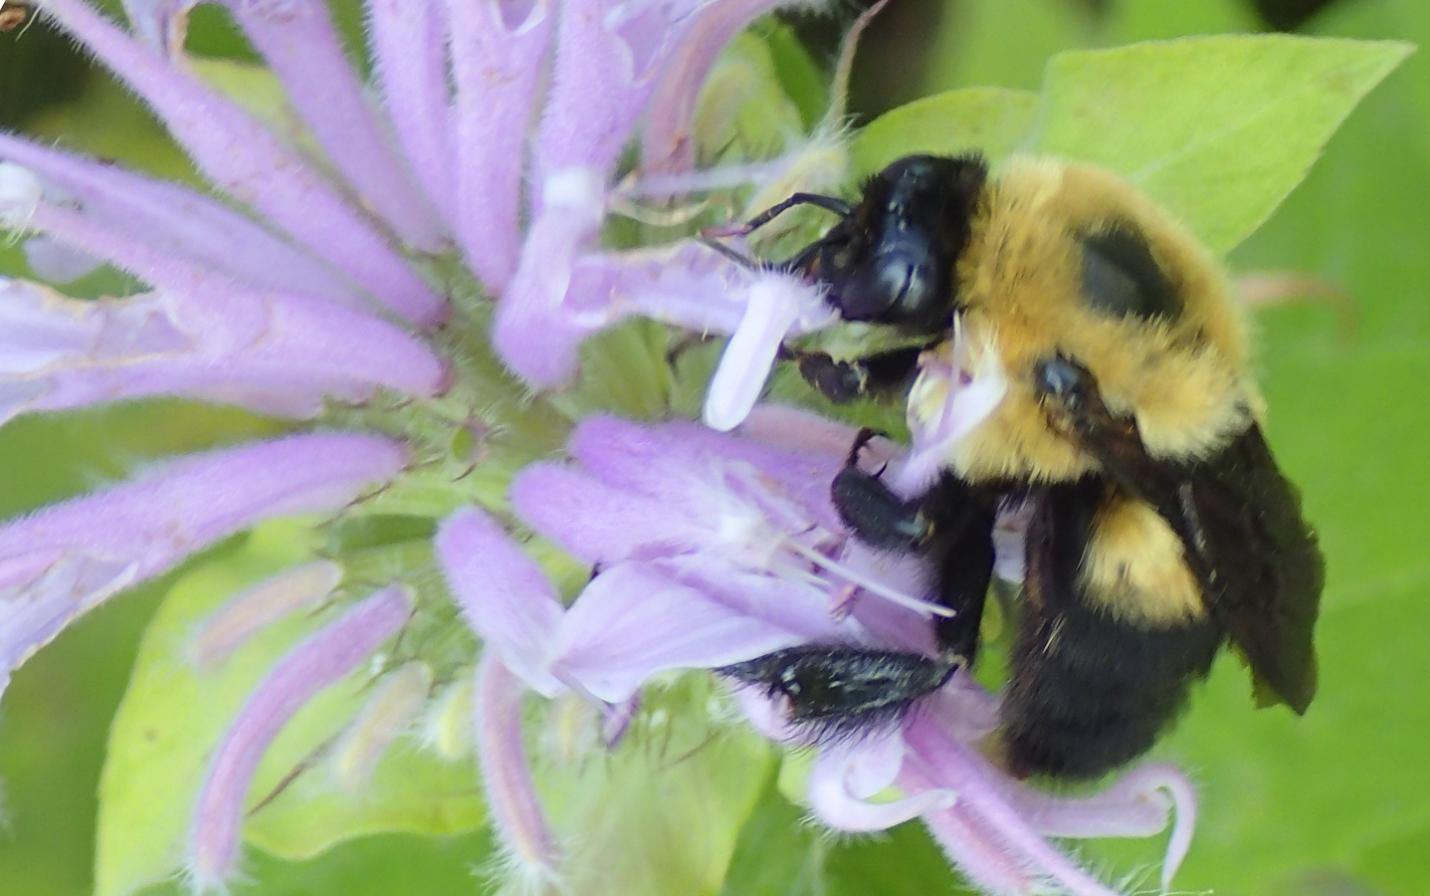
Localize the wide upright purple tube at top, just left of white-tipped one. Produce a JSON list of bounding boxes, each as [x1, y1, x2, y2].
[[446, 0, 551, 294]]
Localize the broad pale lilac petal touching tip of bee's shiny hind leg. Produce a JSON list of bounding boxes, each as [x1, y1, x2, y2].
[[555, 563, 802, 703]]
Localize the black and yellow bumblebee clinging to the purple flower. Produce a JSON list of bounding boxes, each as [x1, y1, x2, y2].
[[728, 156, 1324, 777]]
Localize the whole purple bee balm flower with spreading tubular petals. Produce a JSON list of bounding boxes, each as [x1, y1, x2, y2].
[[0, 0, 1191, 895]]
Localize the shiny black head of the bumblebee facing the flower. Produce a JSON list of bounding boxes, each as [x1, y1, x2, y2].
[[795, 156, 988, 334]]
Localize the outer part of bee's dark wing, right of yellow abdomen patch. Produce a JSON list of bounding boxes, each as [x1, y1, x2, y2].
[[1178, 426, 1326, 713]]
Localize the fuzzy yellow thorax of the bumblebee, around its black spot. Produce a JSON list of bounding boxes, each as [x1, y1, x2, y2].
[[911, 159, 1261, 482]]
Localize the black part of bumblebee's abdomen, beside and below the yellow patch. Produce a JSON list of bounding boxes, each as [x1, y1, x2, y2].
[[1002, 482, 1223, 777]]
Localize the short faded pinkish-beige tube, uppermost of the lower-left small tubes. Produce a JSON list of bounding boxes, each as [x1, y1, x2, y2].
[[187, 560, 343, 669]]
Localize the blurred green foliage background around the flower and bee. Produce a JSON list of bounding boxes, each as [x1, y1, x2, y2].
[[0, 0, 1430, 896]]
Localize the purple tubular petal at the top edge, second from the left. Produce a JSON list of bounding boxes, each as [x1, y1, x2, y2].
[[211, 0, 443, 252]]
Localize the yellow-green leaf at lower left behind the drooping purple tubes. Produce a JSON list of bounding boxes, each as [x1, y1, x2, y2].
[[94, 522, 482, 896]]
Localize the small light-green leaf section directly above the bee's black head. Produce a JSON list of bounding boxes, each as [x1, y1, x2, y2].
[[851, 87, 1038, 174]]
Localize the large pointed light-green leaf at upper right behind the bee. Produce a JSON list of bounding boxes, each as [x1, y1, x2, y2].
[[1035, 34, 1411, 253]]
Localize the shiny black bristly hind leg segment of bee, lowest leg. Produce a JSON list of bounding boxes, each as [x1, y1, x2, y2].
[[716, 644, 960, 735]]
